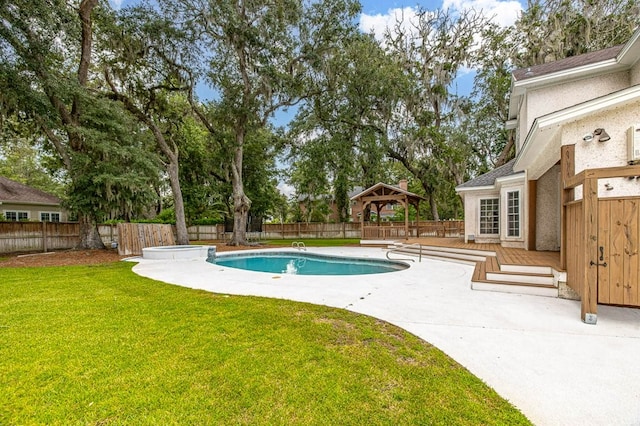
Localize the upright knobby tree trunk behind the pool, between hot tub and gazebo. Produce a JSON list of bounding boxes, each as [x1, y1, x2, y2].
[[229, 140, 251, 246]]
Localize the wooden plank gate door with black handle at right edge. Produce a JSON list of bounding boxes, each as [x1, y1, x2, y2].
[[592, 198, 640, 306]]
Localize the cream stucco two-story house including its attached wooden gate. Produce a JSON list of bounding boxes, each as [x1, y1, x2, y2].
[[456, 30, 640, 322]]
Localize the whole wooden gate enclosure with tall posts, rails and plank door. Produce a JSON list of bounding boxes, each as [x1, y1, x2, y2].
[[560, 145, 640, 318]]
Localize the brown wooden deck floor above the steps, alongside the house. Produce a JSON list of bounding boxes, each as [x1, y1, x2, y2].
[[407, 237, 564, 271]]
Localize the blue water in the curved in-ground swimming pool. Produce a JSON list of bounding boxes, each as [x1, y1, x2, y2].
[[207, 252, 408, 275]]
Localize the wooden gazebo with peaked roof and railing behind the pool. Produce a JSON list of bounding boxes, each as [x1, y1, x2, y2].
[[351, 180, 425, 240]]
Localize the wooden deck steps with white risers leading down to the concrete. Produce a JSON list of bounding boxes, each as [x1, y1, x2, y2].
[[388, 243, 558, 297]]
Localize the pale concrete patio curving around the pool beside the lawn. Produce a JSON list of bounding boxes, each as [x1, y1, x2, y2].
[[133, 247, 640, 425]]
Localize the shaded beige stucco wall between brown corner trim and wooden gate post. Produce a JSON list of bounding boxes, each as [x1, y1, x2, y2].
[[535, 165, 560, 251]]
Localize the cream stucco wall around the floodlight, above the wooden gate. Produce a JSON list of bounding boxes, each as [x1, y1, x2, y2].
[[562, 101, 640, 199]]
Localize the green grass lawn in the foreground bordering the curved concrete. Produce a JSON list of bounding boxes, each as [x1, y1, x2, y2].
[[0, 263, 529, 425]]
